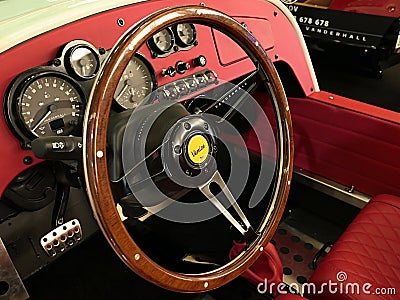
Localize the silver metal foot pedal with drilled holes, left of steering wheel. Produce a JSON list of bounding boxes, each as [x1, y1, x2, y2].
[[40, 219, 82, 256]]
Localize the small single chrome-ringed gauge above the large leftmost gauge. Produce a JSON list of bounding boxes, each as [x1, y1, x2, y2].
[[68, 45, 99, 79]]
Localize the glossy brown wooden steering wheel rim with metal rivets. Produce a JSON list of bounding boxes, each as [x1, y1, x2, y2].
[[83, 5, 293, 292]]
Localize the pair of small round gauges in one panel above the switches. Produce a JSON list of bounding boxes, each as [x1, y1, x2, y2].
[[147, 23, 198, 58]]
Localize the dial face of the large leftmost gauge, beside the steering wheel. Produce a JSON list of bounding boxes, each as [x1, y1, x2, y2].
[[8, 72, 84, 137]]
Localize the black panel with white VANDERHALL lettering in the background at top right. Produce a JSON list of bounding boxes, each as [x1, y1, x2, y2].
[[282, 0, 399, 53]]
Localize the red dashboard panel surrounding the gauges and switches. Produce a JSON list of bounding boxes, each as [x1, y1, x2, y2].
[[0, 1, 316, 194]]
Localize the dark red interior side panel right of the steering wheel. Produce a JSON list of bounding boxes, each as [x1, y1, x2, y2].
[[246, 93, 400, 195]]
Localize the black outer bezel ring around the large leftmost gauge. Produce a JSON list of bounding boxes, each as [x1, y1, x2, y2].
[[4, 66, 87, 144]]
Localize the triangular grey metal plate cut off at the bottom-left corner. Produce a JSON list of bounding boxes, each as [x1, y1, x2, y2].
[[0, 238, 29, 300]]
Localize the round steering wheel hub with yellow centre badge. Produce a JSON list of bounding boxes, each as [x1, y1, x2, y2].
[[161, 115, 217, 187]]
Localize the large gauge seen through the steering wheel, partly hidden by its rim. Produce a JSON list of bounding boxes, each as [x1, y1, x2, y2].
[[114, 53, 157, 109]]
